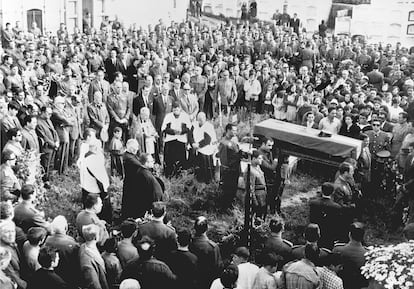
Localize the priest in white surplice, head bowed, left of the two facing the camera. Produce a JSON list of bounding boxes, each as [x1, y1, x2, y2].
[[161, 102, 191, 177]]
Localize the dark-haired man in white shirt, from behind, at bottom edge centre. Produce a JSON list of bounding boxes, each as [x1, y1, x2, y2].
[[233, 247, 259, 289]]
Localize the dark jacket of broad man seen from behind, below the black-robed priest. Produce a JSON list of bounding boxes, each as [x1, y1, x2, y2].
[[138, 220, 177, 262]]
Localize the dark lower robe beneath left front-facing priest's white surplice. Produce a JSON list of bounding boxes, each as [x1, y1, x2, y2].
[[164, 140, 186, 177]]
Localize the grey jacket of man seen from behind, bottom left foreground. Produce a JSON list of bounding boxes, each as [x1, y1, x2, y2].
[[79, 244, 109, 289]]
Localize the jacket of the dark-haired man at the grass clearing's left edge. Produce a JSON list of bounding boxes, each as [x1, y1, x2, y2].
[[13, 201, 50, 233]]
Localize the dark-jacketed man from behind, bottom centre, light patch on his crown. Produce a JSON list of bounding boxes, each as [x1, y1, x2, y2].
[[190, 216, 223, 289]]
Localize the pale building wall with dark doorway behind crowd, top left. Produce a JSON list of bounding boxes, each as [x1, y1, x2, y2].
[[0, 0, 189, 33]]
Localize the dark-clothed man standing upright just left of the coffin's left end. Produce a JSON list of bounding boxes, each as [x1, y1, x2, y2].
[[218, 123, 241, 210]]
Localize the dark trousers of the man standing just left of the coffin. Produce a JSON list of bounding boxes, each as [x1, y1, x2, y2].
[[220, 167, 240, 209]]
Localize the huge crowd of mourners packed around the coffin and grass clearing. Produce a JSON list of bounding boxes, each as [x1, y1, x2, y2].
[[0, 5, 414, 289]]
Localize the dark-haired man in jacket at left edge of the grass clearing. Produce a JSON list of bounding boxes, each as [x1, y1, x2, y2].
[[13, 185, 50, 232]]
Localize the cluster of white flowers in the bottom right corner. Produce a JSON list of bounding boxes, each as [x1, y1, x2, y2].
[[361, 240, 414, 289]]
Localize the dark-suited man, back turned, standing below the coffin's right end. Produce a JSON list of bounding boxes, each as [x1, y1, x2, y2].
[[309, 183, 341, 248]]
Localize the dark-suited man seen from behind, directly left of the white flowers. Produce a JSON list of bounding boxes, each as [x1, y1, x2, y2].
[[333, 222, 368, 289]]
